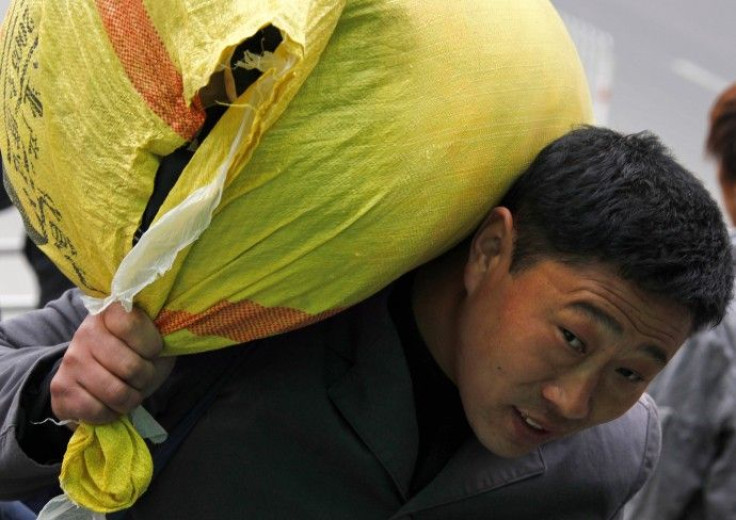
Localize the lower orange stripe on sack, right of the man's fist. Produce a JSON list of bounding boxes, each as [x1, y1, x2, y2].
[[156, 300, 342, 343]]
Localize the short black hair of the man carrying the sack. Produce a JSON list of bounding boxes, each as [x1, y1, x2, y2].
[[500, 126, 733, 331]]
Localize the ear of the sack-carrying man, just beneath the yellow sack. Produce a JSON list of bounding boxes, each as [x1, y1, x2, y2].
[[465, 206, 514, 293]]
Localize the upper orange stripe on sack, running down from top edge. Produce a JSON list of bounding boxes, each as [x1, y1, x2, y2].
[[96, 0, 205, 141]]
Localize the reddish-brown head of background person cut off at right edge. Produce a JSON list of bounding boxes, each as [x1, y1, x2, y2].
[[705, 84, 736, 223]]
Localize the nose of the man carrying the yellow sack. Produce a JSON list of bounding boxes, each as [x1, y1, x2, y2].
[[542, 373, 598, 419]]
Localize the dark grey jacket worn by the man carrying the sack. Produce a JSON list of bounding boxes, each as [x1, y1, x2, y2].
[[0, 291, 660, 520]]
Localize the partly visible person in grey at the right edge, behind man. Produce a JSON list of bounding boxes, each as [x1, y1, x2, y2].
[[626, 84, 736, 520]]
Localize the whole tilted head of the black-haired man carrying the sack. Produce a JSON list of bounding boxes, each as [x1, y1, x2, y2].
[[436, 127, 733, 457]]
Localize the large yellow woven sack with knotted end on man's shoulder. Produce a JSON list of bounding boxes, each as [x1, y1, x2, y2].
[[0, 0, 590, 512]]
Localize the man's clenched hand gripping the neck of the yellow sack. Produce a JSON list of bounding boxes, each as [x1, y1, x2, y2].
[[51, 303, 175, 424]]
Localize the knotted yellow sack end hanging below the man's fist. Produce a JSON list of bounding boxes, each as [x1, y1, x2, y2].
[[59, 417, 153, 513]]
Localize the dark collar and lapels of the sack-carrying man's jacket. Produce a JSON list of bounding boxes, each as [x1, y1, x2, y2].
[[329, 291, 544, 514]]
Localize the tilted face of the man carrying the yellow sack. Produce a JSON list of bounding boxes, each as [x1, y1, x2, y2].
[[453, 213, 691, 457]]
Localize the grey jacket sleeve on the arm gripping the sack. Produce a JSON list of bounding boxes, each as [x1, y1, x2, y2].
[[0, 289, 87, 498]]
